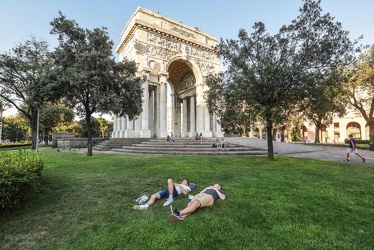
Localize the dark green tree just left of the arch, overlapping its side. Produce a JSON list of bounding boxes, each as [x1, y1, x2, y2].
[[51, 12, 143, 156]]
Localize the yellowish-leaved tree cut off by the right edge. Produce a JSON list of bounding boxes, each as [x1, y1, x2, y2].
[[344, 45, 374, 142]]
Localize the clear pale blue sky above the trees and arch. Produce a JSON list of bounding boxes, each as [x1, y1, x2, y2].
[[0, 0, 374, 116]]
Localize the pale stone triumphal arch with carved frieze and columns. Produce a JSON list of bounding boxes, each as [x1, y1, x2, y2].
[[113, 7, 223, 138]]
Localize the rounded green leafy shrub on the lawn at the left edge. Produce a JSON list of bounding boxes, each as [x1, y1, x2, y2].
[[0, 150, 43, 211]]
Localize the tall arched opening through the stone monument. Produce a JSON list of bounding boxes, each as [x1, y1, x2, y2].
[[168, 59, 197, 137]]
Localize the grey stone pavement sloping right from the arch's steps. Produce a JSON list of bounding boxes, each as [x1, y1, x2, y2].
[[225, 137, 374, 165]]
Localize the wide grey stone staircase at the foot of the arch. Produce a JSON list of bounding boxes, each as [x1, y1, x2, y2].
[[94, 137, 267, 155]]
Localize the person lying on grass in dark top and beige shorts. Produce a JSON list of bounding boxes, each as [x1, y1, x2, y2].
[[169, 183, 226, 221]]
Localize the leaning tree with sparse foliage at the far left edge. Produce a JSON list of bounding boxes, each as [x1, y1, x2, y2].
[[0, 37, 55, 149]]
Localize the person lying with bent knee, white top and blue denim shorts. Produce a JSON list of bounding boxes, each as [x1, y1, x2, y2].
[[134, 179, 191, 210]]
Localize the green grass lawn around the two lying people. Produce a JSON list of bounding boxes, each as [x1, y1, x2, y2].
[[0, 149, 374, 250]]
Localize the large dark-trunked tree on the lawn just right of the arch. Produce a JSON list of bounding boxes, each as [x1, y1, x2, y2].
[[207, 0, 355, 160]]
